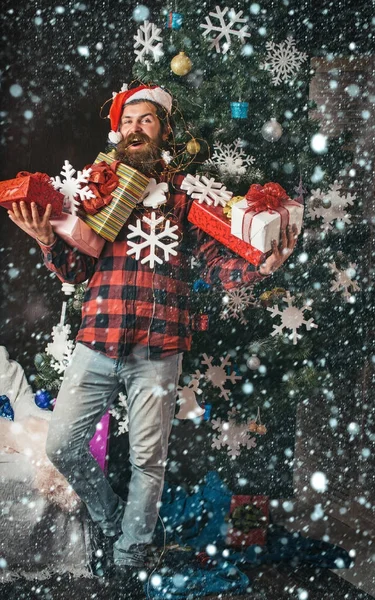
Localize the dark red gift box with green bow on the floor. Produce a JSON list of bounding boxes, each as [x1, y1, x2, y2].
[[225, 496, 269, 548]]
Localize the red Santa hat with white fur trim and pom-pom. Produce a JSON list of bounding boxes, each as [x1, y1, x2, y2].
[[108, 85, 172, 144]]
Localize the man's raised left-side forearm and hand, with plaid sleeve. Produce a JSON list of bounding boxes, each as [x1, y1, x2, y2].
[[8, 202, 96, 284]]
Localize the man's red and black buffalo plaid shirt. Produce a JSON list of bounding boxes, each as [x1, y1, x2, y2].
[[41, 174, 264, 359]]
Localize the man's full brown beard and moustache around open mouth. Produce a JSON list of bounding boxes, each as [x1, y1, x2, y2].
[[115, 133, 163, 174]]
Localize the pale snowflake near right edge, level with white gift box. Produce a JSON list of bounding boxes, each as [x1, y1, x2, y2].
[[308, 181, 356, 230]]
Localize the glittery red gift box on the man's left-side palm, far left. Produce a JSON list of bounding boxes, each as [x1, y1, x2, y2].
[[0, 173, 64, 217]]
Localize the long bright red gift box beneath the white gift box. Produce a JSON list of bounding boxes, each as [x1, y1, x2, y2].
[[188, 200, 267, 266]]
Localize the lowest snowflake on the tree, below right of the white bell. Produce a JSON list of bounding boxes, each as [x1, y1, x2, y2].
[[211, 408, 257, 458]]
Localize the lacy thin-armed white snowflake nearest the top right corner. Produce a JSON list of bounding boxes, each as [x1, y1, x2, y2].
[[261, 37, 307, 85]]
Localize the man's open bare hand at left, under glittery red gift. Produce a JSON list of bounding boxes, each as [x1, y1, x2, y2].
[[8, 202, 56, 246]]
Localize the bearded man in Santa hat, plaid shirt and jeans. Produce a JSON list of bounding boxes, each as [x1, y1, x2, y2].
[[10, 85, 296, 592]]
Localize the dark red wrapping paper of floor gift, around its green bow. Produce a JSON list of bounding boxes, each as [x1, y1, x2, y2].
[[225, 495, 269, 548]]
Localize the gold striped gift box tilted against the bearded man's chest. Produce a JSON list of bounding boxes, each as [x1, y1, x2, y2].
[[80, 152, 150, 242]]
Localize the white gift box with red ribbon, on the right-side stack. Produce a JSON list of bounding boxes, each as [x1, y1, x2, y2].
[[231, 198, 303, 252]]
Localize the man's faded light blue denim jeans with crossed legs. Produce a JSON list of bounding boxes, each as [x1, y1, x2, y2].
[[46, 343, 182, 564]]
